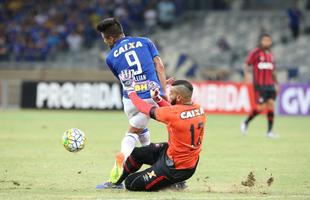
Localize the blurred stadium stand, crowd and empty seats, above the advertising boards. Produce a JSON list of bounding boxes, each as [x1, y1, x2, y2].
[[0, 0, 310, 81]]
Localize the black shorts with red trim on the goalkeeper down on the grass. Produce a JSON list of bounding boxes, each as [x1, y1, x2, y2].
[[125, 143, 198, 191]]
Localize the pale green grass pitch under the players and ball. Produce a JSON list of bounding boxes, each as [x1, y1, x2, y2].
[[0, 110, 310, 200]]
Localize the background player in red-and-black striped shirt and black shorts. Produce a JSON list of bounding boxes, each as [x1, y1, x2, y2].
[[241, 34, 277, 138]]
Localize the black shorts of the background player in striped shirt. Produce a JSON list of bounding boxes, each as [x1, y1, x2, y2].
[[254, 86, 276, 104]]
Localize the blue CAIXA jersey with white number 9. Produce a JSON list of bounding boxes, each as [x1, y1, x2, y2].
[[106, 37, 163, 99]]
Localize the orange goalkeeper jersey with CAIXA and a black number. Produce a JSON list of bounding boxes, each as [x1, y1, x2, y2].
[[155, 105, 206, 169]]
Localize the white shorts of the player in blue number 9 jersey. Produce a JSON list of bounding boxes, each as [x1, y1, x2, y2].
[[123, 97, 157, 129]]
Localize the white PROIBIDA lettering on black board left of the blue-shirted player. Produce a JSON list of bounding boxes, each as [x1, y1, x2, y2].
[[36, 82, 122, 109]]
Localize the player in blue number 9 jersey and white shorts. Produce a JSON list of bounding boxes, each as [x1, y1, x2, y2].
[[97, 18, 166, 189]]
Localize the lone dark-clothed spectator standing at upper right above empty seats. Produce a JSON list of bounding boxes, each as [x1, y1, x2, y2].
[[287, 1, 302, 39]]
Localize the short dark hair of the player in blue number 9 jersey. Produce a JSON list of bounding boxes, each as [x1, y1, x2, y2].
[[97, 18, 124, 37]]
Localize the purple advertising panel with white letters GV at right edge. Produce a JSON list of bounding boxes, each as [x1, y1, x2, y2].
[[279, 84, 310, 115]]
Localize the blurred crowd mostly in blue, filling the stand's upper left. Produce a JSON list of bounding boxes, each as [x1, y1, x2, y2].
[[0, 0, 182, 61]]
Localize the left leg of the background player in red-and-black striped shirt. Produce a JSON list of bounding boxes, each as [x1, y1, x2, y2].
[[240, 90, 266, 135]]
